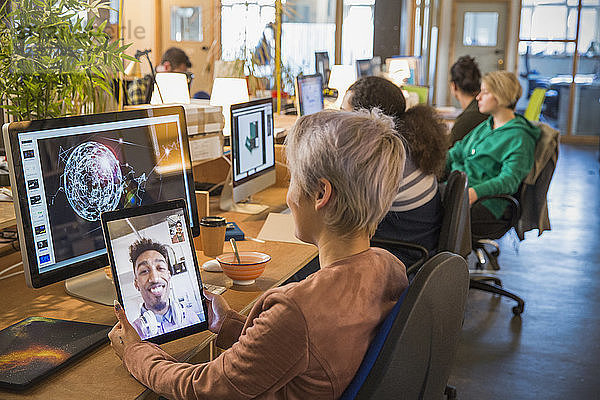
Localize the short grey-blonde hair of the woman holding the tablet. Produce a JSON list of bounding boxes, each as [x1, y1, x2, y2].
[[286, 109, 406, 237]]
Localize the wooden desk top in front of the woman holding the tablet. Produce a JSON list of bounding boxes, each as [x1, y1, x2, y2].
[[0, 187, 317, 400]]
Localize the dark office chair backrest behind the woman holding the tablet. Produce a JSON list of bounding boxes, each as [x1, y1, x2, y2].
[[341, 252, 469, 400]]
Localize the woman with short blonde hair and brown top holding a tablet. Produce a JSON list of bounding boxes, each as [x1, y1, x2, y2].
[[109, 111, 408, 399]]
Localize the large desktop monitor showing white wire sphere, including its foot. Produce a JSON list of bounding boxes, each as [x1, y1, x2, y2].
[[3, 106, 200, 304]]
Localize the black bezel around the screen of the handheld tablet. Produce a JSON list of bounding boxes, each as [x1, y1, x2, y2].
[[101, 199, 208, 344]]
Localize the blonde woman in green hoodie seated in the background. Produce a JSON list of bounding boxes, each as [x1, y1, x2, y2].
[[446, 71, 540, 230]]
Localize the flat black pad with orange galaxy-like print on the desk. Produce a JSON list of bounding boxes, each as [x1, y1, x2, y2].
[[0, 317, 112, 390]]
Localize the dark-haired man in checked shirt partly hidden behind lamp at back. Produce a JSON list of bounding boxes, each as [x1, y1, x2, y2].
[[127, 47, 192, 105]]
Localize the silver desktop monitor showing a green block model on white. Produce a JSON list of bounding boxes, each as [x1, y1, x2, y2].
[[220, 98, 276, 214]]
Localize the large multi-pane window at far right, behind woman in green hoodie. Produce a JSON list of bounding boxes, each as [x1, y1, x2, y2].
[[517, 0, 600, 136]]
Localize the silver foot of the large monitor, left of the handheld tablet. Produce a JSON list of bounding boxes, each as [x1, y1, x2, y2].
[[65, 269, 117, 306]]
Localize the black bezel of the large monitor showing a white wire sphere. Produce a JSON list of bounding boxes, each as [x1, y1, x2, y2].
[[2, 106, 200, 288]]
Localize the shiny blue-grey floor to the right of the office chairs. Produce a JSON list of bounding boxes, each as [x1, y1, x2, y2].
[[450, 145, 600, 399]]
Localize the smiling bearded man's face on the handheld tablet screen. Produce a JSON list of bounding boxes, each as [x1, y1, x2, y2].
[[133, 250, 171, 312]]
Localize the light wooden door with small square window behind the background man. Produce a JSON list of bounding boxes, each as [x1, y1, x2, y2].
[[161, 0, 218, 95]]
